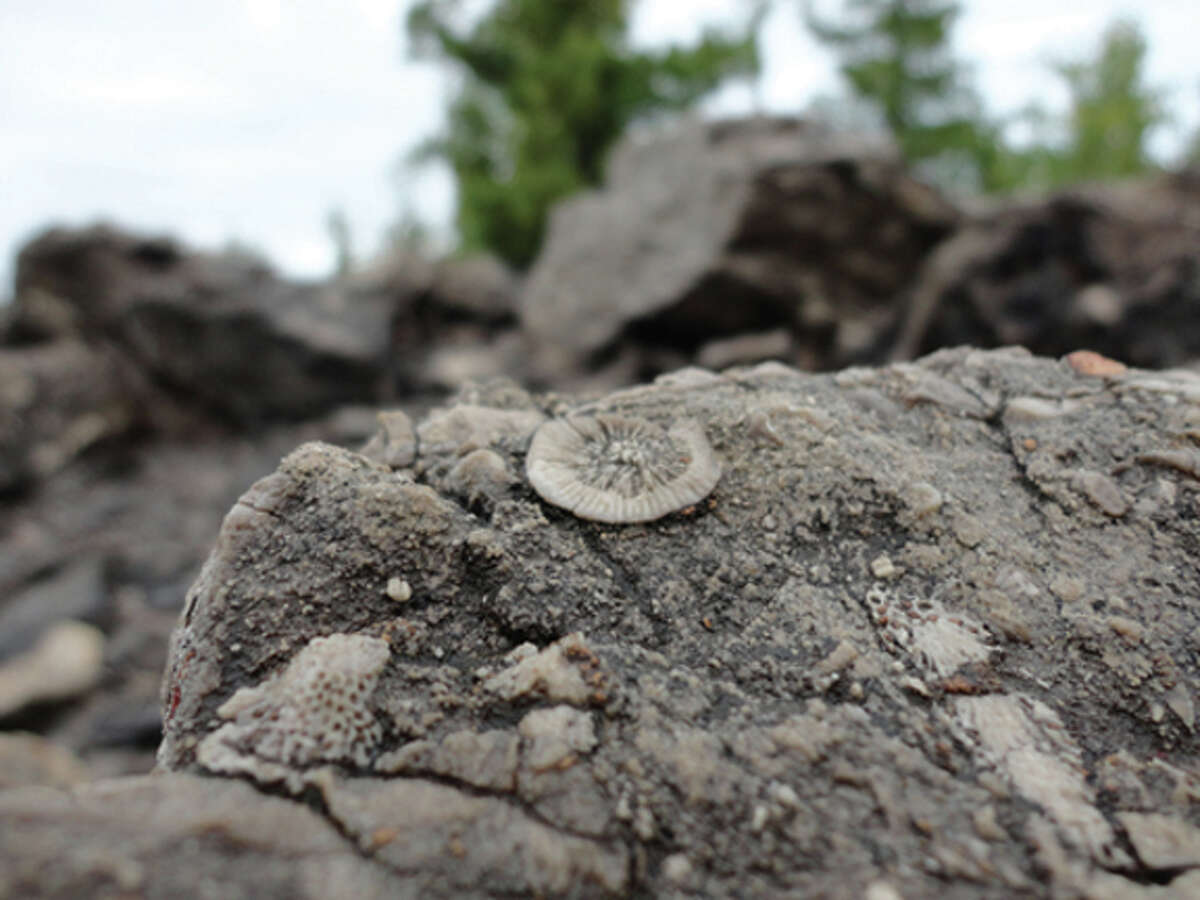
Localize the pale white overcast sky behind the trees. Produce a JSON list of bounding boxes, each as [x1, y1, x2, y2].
[[0, 0, 1200, 298]]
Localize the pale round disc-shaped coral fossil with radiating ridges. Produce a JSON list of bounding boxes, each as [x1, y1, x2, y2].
[[526, 414, 721, 523]]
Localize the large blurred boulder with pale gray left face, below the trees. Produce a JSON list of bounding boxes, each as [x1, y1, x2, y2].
[[521, 119, 958, 378]]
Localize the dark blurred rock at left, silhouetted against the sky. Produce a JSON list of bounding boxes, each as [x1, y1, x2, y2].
[[12, 226, 397, 424]]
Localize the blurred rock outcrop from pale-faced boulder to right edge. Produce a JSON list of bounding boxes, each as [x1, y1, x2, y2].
[[521, 119, 1200, 386]]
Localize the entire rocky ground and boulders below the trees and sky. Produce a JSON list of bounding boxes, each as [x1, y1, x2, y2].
[[0, 120, 1200, 900]]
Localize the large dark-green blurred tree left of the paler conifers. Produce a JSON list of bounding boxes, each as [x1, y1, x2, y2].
[[408, 0, 761, 268]]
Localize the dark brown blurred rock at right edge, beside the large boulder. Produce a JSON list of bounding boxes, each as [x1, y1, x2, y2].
[[890, 170, 1200, 368]]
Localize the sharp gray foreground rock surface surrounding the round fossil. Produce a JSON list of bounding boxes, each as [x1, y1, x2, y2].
[[150, 349, 1200, 900]]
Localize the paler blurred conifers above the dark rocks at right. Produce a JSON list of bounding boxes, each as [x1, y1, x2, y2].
[[804, 6, 1165, 192]]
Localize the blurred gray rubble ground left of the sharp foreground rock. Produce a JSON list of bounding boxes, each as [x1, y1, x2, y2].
[[0, 409, 376, 775]]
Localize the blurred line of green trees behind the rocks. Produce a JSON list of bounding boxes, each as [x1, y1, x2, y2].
[[407, 0, 1200, 269]]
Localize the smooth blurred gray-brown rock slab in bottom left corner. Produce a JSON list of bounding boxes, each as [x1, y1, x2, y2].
[[0, 775, 396, 900]]
